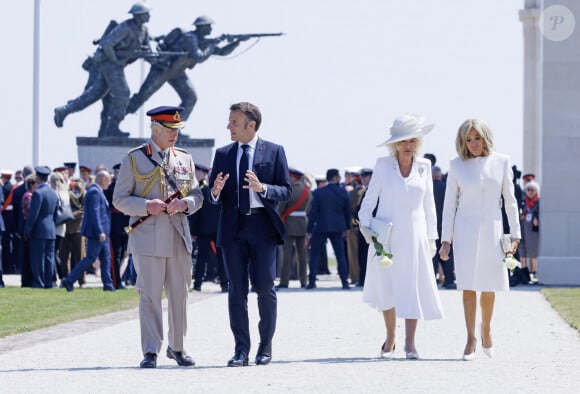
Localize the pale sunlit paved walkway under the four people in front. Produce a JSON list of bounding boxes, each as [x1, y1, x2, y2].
[[0, 275, 580, 394]]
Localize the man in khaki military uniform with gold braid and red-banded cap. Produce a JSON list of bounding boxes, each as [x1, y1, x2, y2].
[[113, 107, 203, 368]]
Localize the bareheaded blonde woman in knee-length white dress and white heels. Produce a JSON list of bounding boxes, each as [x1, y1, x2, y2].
[[439, 119, 521, 361]]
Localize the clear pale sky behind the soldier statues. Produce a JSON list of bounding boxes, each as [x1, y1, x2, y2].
[[0, 0, 524, 174]]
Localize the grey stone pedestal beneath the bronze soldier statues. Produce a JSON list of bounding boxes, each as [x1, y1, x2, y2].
[[77, 137, 215, 171]]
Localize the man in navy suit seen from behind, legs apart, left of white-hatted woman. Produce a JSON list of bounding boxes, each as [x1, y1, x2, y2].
[[306, 168, 351, 290]]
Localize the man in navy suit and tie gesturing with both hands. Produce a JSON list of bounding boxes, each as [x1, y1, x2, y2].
[[209, 102, 292, 367]]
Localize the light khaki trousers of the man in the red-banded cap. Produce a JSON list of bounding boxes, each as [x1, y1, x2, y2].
[[133, 235, 192, 354]]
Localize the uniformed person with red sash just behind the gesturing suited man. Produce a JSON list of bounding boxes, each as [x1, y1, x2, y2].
[[277, 168, 312, 289]]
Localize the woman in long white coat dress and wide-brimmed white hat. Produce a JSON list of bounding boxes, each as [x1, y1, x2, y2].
[[359, 115, 443, 359]]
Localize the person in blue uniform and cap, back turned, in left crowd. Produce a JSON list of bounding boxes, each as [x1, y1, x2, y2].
[[24, 166, 58, 289]]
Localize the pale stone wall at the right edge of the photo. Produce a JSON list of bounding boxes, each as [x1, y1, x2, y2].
[[538, 0, 580, 285]]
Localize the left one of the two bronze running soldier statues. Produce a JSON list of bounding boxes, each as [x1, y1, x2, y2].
[[54, 3, 151, 137]]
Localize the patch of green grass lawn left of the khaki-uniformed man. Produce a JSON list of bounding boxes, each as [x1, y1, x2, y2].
[[0, 287, 139, 338]]
